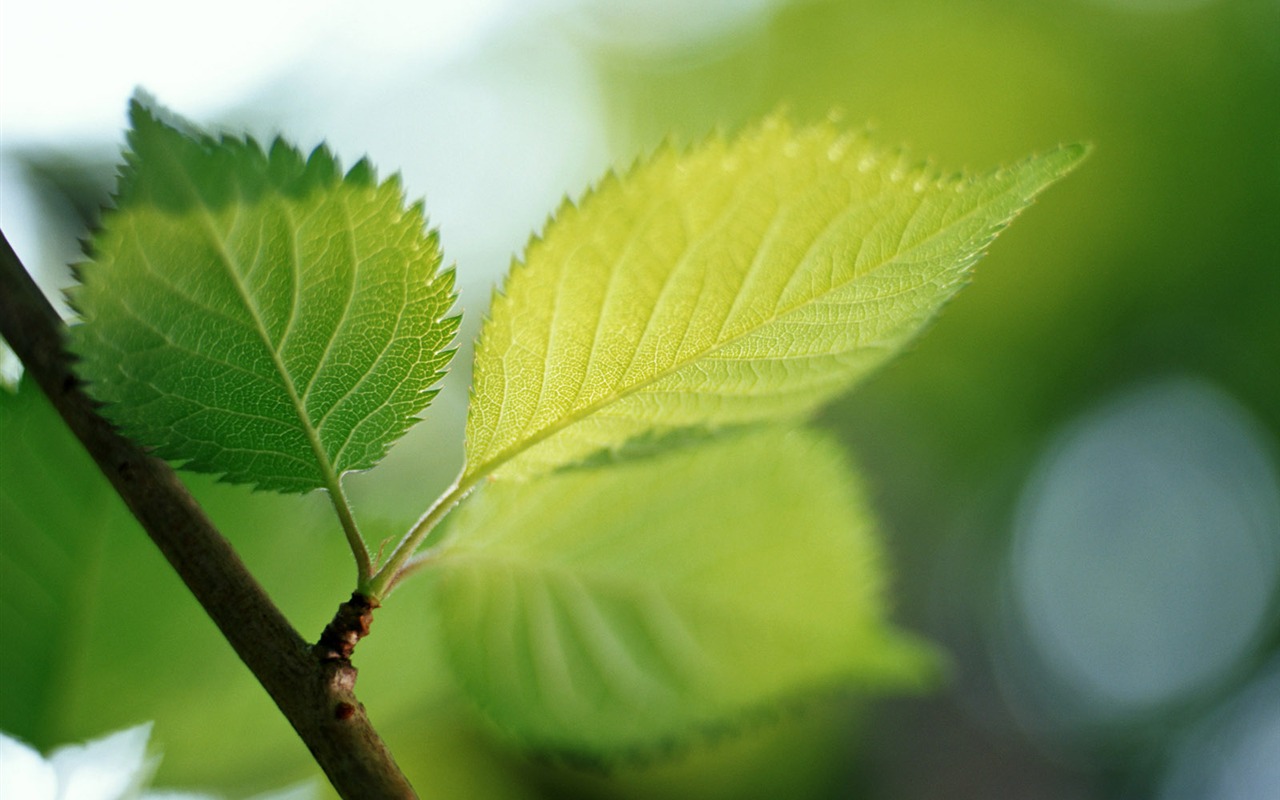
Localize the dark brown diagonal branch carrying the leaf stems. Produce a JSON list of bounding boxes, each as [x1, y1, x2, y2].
[[0, 233, 416, 800]]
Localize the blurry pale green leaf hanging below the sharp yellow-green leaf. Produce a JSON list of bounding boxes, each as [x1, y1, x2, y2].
[[429, 428, 932, 751]]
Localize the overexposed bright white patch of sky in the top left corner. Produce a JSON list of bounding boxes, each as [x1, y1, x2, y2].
[[0, 0, 511, 147]]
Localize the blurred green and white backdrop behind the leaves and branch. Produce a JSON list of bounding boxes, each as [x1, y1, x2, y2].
[[0, 0, 1280, 799]]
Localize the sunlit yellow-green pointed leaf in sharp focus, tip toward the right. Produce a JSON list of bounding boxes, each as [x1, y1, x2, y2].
[[462, 118, 1085, 484]]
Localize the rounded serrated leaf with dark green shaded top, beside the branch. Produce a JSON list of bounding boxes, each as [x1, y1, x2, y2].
[[72, 101, 457, 492]]
